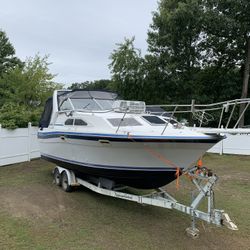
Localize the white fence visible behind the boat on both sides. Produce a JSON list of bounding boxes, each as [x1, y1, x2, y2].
[[0, 123, 250, 166]]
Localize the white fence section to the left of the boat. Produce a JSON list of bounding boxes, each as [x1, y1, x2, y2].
[[0, 123, 40, 166]]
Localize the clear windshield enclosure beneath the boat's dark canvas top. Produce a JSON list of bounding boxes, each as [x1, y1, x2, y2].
[[58, 90, 117, 110]]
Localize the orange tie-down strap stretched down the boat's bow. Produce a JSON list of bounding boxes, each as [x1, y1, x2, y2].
[[128, 133, 181, 190]]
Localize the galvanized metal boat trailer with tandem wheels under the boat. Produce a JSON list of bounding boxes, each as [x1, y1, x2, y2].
[[53, 166, 238, 238]]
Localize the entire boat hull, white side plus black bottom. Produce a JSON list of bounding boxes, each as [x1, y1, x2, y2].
[[40, 133, 218, 188]]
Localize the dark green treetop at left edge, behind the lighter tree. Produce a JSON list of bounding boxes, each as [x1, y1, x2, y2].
[[0, 30, 22, 77]]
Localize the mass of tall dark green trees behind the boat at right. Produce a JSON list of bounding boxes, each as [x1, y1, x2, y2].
[[110, 0, 250, 109]]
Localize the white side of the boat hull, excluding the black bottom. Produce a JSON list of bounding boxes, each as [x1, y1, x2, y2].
[[40, 138, 214, 169]]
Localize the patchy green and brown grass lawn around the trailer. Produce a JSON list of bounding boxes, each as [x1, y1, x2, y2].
[[0, 154, 250, 250]]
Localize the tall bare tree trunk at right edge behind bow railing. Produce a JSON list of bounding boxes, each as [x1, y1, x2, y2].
[[239, 37, 250, 128]]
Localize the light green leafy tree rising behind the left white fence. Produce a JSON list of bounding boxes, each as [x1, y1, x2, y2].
[[0, 55, 61, 128]]
